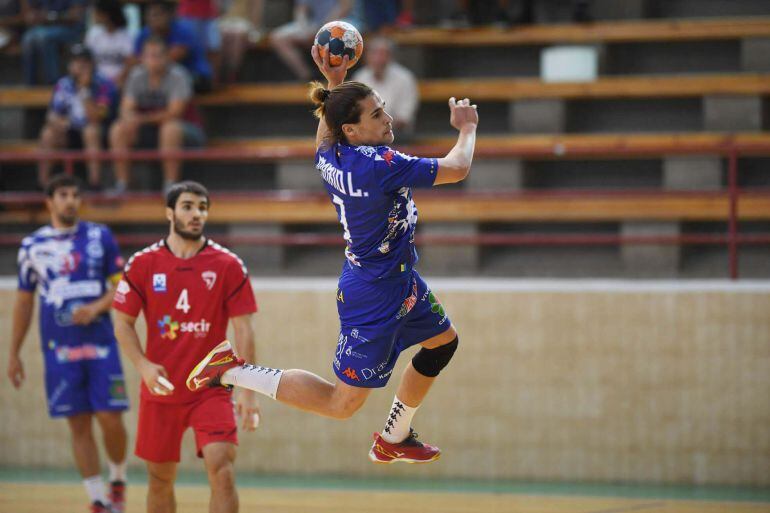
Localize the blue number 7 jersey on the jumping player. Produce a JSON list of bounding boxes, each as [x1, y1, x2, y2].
[[316, 143, 438, 281]]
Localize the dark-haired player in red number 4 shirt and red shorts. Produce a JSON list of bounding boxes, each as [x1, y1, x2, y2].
[[113, 182, 259, 513]]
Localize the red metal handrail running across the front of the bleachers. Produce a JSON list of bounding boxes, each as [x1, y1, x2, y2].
[[0, 138, 770, 279]]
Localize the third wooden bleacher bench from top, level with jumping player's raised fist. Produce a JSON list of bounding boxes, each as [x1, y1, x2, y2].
[[0, 132, 770, 158]]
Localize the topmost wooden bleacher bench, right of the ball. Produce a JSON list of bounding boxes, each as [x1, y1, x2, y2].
[[390, 16, 770, 47]]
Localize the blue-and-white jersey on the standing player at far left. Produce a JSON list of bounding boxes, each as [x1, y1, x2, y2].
[[18, 222, 123, 352]]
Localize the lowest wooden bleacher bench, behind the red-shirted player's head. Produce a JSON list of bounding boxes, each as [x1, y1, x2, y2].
[[0, 190, 770, 224]]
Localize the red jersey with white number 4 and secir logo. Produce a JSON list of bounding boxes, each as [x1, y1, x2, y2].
[[112, 240, 257, 403]]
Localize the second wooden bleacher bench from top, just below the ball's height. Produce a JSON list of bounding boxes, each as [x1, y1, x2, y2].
[[0, 73, 770, 108]]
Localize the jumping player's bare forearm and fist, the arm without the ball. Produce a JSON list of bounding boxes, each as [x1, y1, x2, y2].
[[433, 97, 479, 185]]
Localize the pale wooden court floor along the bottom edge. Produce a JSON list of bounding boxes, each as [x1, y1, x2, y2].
[[0, 480, 770, 513]]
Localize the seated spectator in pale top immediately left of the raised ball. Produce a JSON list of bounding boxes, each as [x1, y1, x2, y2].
[[270, 0, 353, 81]]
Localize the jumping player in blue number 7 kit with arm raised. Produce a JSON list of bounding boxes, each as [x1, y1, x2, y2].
[[187, 47, 478, 463]]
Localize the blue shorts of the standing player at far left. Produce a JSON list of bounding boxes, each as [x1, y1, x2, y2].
[[44, 340, 128, 417]]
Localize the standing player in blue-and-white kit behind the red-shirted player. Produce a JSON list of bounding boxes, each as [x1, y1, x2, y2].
[[7, 175, 128, 513]]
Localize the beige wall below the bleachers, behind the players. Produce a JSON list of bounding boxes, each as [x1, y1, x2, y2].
[[0, 280, 770, 486]]
